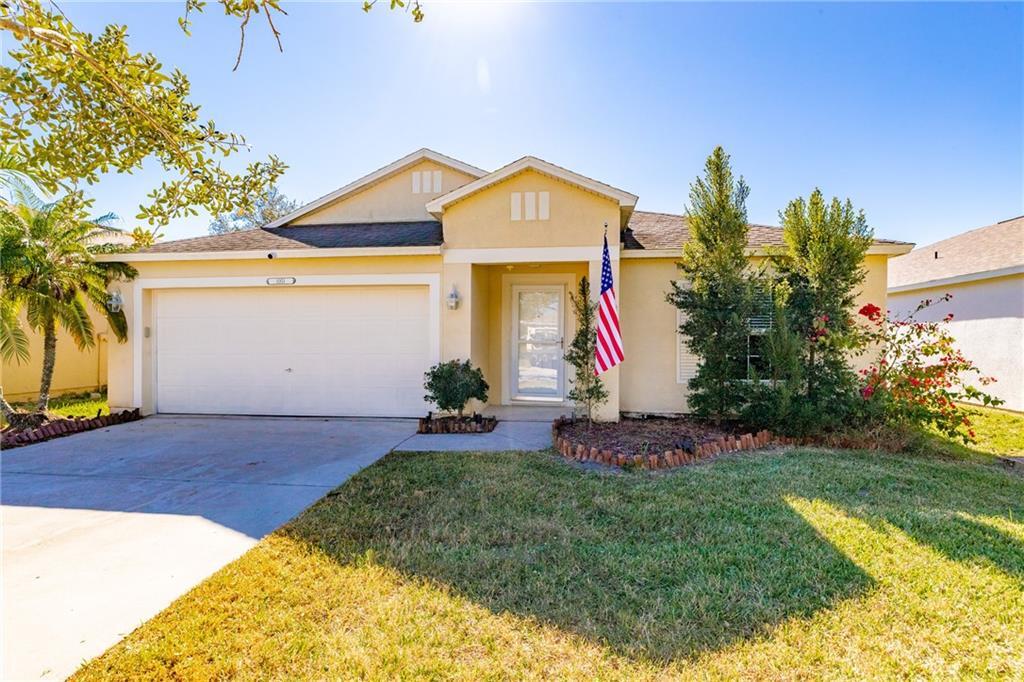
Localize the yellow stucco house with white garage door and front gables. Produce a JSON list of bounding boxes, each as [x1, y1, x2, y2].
[[96, 150, 910, 419]]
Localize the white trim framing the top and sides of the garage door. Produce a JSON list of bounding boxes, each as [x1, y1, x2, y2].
[[126, 272, 441, 408]]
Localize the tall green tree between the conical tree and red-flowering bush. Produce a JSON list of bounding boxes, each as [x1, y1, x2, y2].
[[773, 189, 872, 405]]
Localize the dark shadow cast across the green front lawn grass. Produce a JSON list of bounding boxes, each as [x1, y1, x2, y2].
[[285, 451, 1024, 663]]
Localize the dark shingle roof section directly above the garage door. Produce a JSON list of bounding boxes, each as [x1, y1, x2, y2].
[[139, 220, 441, 253]]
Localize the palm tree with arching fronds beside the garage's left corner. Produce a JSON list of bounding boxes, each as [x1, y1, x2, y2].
[[0, 186, 136, 423]]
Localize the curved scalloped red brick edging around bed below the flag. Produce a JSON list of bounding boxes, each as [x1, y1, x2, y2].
[[551, 417, 782, 469]]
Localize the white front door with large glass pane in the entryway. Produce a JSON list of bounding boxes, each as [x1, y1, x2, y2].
[[511, 285, 565, 402]]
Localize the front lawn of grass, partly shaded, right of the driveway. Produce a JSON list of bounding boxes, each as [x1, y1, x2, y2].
[[77, 449, 1024, 680]]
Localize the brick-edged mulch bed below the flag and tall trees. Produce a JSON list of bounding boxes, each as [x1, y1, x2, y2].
[[551, 418, 788, 469]]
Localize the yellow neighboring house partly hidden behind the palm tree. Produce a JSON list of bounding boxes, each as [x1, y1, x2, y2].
[[0, 228, 132, 402]]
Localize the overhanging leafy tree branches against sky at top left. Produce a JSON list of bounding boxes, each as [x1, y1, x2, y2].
[[0, 0, 423, 225]]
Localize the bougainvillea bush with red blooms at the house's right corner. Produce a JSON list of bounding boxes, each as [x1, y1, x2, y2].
[[858, 294, 1002, 443]]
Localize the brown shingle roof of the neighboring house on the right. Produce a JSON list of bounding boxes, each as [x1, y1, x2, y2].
[[889, 216, 1024, 287]]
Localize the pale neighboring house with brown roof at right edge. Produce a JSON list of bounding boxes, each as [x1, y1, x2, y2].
[[889, 216, 1024, 412]]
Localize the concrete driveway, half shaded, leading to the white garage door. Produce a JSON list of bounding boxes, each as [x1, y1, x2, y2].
[[0, 417, 415, 680]]
